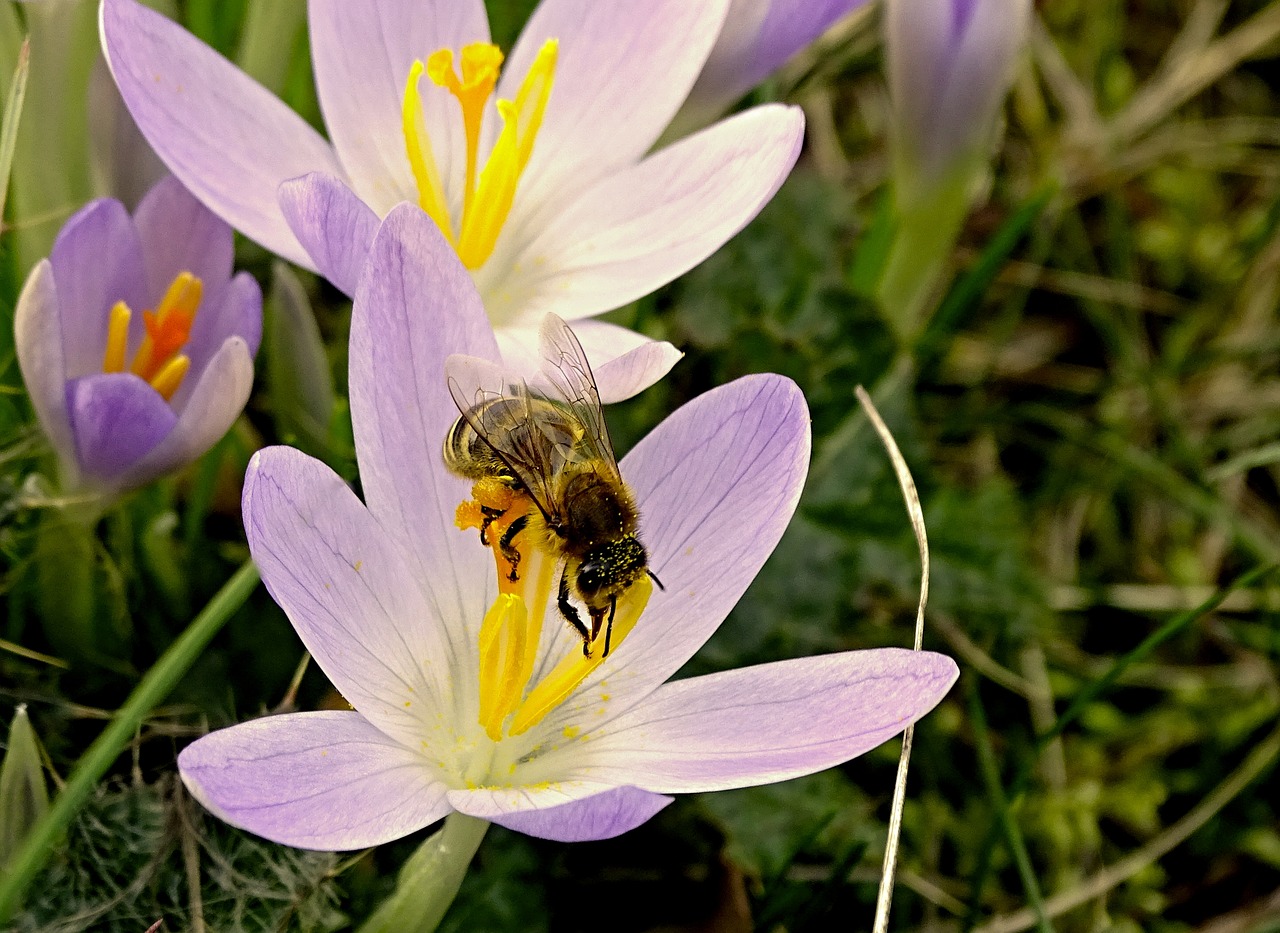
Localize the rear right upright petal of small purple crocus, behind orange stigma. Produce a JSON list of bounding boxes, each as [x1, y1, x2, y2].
[[133, 175, 234, 298]]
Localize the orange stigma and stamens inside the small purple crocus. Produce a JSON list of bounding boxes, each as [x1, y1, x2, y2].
[[102, 273, 204, 402]]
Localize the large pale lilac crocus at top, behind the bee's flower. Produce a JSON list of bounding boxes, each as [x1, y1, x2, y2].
[[102, 0, 804, 401]]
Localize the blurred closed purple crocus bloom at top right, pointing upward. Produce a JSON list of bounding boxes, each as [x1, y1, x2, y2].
[[884, 0, 1032, 200]]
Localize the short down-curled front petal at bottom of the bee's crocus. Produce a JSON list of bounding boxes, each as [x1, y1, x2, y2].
[[449, 787, 672, 842]]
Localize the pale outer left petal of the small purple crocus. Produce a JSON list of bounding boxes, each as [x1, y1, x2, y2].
[[13, 260, 79, 485]]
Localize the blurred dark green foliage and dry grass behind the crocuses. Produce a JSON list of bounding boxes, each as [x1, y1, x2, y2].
[[0, 0, 1280, 933]]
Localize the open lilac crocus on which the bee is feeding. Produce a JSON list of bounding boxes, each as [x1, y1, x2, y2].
[[178, 206, 957, 850]]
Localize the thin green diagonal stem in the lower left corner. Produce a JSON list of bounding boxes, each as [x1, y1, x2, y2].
[[0, 561, 259, 924]]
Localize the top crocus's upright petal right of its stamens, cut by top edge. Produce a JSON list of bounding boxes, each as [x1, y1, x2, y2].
[[498, 0, 728, 214]]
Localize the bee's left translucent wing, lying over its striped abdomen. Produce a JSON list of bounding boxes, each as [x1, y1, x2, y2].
[[444, 353, 579, 516]]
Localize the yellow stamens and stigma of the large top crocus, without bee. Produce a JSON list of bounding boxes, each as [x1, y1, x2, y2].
[[401, 38, 558, 269]]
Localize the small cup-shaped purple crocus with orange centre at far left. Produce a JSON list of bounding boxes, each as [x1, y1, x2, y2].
[[14, 178, 262, 493]]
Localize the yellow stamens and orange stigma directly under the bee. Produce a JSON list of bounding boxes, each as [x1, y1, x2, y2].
[[457, 480, 653, 742]]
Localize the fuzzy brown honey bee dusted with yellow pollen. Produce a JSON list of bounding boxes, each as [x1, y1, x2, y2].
[[444, 315, 662, 658]]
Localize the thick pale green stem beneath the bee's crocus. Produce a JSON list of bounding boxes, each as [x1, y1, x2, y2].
[[360, 811, 489, 933]]
